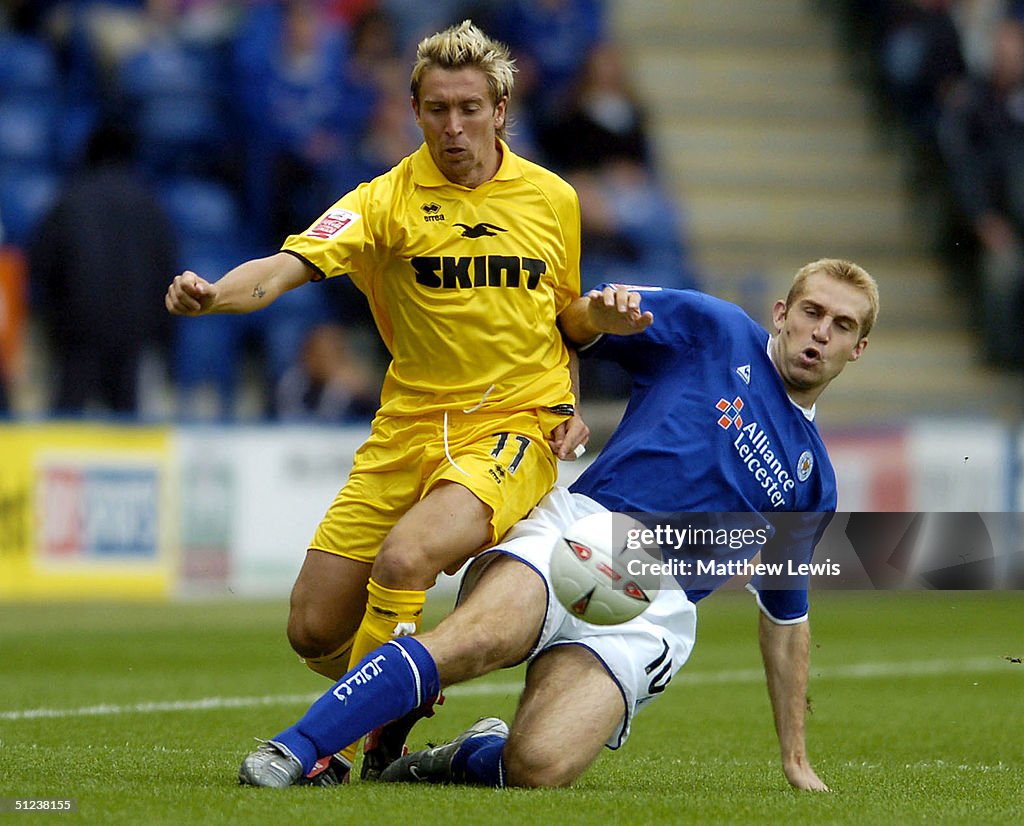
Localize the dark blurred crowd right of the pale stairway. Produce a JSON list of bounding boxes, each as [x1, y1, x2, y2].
[[825, 0, 1024, 369]]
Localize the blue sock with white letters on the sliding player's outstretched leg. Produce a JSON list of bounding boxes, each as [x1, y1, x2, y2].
[[271, 637, 441, 773]]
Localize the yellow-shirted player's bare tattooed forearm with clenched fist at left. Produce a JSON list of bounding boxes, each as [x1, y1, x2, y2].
[[164, 253, 309, 315]]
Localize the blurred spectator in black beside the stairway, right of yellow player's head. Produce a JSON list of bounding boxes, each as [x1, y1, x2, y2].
[[538, 41, 651, 172]]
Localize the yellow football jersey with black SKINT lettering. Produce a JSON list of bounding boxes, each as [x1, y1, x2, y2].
[[282, 142, 580, 416]]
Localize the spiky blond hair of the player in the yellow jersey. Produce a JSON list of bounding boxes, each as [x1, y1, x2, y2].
[[410, 20, 516, 137]]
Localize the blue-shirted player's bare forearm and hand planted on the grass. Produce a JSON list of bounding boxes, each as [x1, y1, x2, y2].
[[758, 613, 829, 791]]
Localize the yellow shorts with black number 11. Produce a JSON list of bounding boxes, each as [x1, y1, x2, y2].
[[309, 409, 566, 562]]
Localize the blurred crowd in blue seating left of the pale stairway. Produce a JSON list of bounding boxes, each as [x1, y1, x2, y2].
[[0, 0, 696, 422]]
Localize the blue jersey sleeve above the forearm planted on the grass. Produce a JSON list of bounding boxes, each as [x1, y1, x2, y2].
[[746, 511, 835, 625]]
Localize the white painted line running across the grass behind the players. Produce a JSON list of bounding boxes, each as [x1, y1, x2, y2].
[[0, 657, 1024, 722]]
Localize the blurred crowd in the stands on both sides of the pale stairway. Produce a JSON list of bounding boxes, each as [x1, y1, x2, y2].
[[8, 0, 1024, 421]]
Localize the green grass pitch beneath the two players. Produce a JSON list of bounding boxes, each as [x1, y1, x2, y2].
[[0, 592, 1024, 826]]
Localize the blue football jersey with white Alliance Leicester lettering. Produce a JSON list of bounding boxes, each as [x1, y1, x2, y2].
[[571, 290, 836, 621]]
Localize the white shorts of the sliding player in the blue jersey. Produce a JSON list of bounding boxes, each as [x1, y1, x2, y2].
[[459, 487, 697, 748]]
